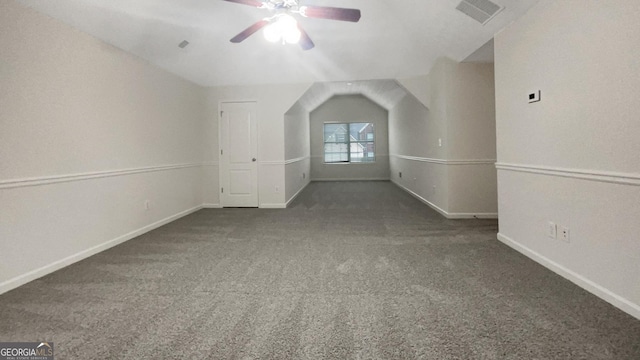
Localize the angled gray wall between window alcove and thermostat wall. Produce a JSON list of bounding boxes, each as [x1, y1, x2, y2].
[[389, 58, 498, 218]]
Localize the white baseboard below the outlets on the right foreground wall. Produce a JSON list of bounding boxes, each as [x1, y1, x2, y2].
[[498, 233, 640, 320]]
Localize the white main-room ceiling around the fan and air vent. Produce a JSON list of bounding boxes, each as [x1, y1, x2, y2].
[[18, 0, 539, 86]]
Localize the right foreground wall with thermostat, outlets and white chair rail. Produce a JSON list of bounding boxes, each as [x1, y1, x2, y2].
[[495, 0, 640, 318]]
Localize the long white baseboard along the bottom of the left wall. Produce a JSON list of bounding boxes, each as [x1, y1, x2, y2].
[[0, 206, 202, 294]]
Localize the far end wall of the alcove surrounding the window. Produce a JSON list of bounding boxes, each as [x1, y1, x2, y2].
[[309, 95, 389, 180]]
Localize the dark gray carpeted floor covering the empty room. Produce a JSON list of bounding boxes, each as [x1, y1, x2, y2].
[[0, 182, 640, 360]]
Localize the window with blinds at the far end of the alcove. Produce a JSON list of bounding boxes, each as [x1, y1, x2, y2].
[[324, 123, 375, 163]]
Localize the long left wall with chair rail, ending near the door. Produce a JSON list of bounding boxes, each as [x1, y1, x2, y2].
[[0, 1, 204, 293]]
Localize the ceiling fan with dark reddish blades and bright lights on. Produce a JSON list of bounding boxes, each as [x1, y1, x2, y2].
[[224, 0, 360, 50]]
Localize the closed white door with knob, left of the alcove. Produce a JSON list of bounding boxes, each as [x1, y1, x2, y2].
[[220, 102, 258, 207]]
